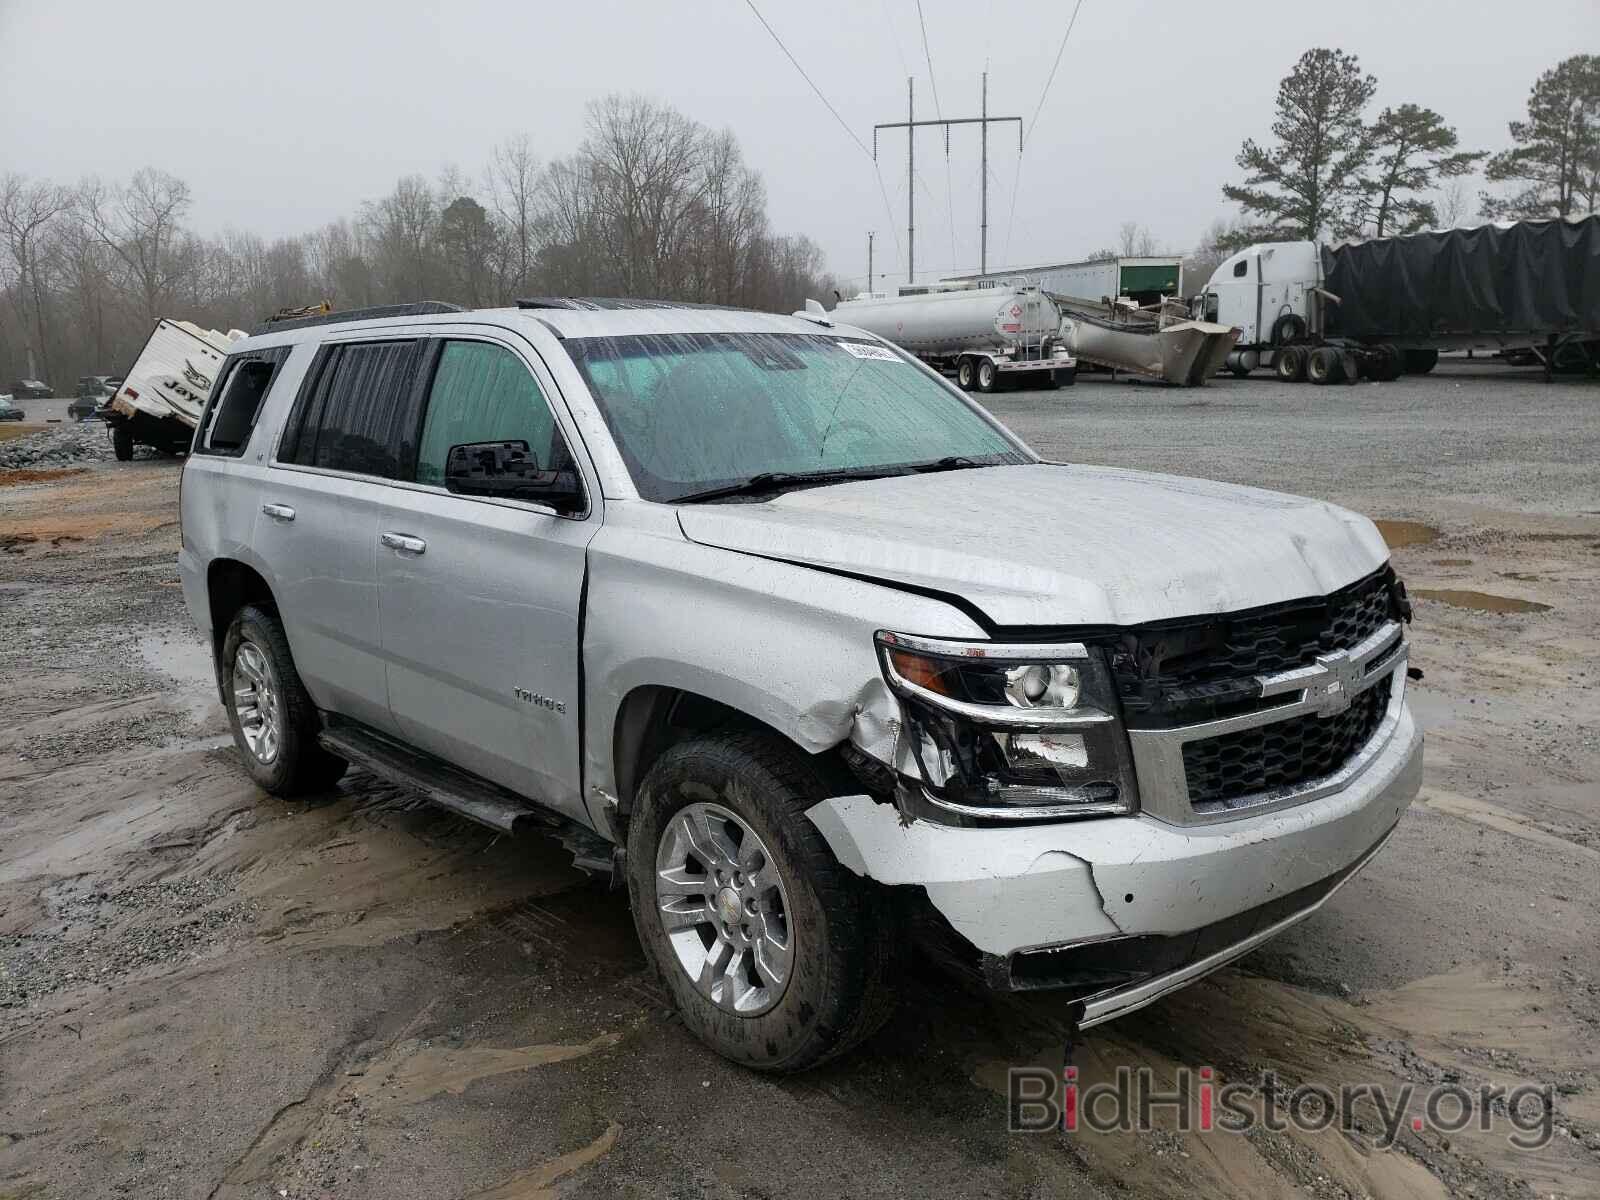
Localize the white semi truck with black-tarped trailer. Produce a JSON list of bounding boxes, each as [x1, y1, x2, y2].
[[1190, 216, 1600, 384]]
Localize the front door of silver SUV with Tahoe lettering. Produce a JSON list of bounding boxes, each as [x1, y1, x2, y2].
[[378, 331, 600, 819]]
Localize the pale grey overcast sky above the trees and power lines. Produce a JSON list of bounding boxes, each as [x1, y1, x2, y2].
[[0, 0, 1600, 289]]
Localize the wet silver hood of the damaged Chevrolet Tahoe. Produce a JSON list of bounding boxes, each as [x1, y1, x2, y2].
[[678, 464, 1389, 634]]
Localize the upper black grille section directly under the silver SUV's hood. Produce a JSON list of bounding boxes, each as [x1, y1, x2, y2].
[[1112, 566, 1397, 728]]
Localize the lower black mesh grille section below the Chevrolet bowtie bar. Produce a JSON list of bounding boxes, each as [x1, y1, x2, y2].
[[1184, 675, 1394, 811]]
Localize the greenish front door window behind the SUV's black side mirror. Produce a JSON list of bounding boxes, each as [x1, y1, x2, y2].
[[416, 341, 570, 486]]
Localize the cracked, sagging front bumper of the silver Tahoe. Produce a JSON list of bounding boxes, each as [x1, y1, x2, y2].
[[808, 706, 1422, 1026]]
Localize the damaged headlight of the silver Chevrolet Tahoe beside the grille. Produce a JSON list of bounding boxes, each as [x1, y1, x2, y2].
[[877, 632, 1138, 821]]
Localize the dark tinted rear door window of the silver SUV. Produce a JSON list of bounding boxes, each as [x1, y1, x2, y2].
[[278, 341, 421, 478]]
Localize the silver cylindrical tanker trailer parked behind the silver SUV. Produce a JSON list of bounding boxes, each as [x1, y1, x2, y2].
[[837, 283, 1078, 392]]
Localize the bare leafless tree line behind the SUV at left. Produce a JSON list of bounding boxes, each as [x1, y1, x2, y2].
[[0, 96, 834, 394]]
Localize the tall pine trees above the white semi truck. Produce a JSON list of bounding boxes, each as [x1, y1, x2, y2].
[[1200, 48, 1600, 253]]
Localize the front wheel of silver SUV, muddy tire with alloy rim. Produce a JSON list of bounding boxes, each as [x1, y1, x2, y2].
[[627, 733, 899, 1072]]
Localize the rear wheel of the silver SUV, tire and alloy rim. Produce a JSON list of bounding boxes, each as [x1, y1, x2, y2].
[[221, 605, 349, 797]]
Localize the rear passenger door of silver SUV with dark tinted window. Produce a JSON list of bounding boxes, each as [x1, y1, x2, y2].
[[254, 338, 422, 733]]
